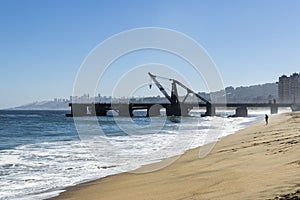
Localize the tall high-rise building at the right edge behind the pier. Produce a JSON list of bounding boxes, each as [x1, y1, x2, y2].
[[278, 73, 300, 103]]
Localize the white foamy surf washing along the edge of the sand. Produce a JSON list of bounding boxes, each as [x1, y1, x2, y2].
[[0, 113, 262, 200]]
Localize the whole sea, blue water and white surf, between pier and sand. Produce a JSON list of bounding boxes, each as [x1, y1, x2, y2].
[[0, 110, 262, 199]]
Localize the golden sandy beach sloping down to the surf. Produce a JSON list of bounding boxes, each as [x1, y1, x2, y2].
[[53, 113, 300, 200]]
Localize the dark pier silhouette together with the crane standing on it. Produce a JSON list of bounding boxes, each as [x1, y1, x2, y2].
[[66, 72, 300, 117]]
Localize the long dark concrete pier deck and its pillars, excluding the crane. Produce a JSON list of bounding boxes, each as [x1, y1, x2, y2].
[[66, 103, 300, 117]]
